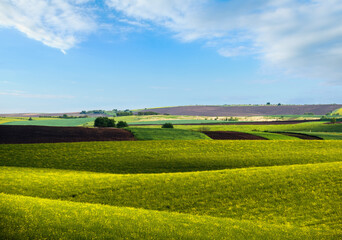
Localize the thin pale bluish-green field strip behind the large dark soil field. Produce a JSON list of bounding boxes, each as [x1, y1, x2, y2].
[[4, 118, 95, 127]]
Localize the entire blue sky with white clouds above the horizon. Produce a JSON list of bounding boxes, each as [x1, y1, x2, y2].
[[0, 0, 342, 113]]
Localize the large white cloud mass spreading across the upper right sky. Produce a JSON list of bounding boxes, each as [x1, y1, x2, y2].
[[107, 0, 342, 83]]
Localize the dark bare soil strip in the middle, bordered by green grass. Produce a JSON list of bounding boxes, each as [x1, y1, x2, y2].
[[203, 131, 267, 140]]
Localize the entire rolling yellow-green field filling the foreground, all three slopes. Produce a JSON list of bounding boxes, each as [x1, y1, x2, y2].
[[0, 139, 342, 239]]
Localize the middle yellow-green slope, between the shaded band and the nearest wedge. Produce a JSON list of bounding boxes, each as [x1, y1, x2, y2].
[[0, 162, 342, 230]]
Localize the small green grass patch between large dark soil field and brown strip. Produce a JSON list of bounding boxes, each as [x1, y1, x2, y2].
[[127, 127, 211, 140]]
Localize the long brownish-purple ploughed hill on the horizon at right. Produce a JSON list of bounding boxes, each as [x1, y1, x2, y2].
[[142, 104, 342, 117]]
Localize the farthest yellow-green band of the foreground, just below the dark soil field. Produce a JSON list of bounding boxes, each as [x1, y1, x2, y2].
[[0, 140, 342, 173]]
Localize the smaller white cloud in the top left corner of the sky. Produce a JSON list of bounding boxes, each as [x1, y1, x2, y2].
[[0, 0, 96, 53]]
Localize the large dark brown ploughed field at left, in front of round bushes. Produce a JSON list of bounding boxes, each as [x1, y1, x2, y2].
[[0, 125, 135, 144]]
